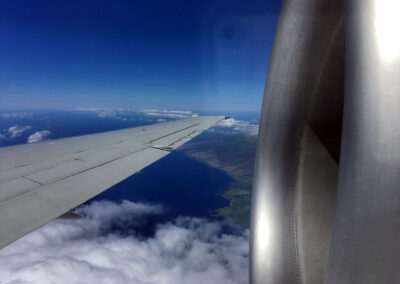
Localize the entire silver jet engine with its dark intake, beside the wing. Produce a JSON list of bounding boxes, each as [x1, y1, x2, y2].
[[250, 0, 400, 284]]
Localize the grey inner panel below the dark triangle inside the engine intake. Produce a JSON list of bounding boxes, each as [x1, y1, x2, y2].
[[295, 127, 338, 284]]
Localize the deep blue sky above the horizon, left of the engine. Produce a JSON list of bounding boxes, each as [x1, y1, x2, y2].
[[0, 0, 281, 111]]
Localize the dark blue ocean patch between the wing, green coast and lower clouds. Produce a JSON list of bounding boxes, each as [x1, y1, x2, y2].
[[90, 151, 233, 236]]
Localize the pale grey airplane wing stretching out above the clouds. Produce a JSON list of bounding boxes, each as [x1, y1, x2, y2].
[[0, 116, 223, 248]]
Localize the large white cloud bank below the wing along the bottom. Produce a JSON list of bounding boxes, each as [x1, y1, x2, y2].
[[0, 201, 248, 284]]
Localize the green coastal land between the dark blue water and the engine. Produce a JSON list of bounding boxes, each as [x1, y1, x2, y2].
[[180, 132, 257, 228]]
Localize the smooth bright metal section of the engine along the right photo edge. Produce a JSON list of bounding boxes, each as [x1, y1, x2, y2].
[[324, 0, 400, 284]]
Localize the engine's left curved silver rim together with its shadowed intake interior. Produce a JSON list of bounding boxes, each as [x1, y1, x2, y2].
[[250, 0, 344, 284]]
